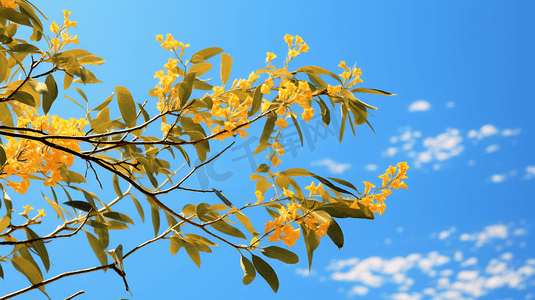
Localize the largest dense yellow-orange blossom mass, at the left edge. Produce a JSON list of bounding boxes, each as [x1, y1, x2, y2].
[[0, 104, 88, 194]]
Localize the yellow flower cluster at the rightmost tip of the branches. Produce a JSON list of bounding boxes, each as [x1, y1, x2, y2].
[[351, 162, 409, 215]]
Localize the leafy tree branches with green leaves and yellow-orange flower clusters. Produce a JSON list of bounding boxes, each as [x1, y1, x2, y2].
[[0, 0, 409, 299]]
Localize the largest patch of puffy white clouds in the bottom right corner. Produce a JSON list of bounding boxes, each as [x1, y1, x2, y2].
[[320, 224, 535, 299]]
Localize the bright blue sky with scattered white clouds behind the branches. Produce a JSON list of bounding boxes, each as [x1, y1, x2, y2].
[[4, 1, 535, 300]]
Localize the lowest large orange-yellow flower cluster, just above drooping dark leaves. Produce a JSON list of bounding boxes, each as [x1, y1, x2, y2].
[[265, 200, 329, 247]]
